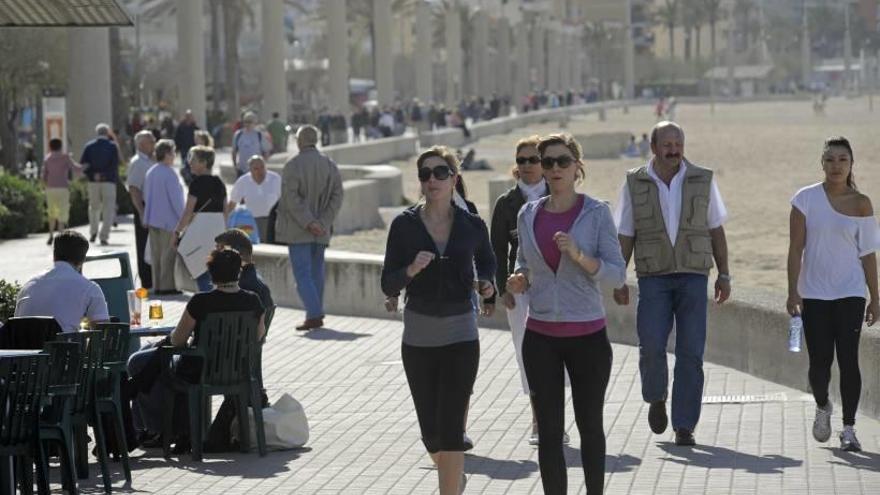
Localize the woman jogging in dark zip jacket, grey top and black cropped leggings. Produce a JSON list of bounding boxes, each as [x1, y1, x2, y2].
[[382, 146, 495, 495]]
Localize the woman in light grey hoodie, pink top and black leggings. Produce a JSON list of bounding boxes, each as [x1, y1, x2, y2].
[[507, 134, 626, 494]]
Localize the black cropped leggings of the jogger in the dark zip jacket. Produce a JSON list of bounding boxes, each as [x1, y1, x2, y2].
[[401, 340, 480, 454]]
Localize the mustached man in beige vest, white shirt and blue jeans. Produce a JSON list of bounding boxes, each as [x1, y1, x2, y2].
[[614, 121, 731, 445]]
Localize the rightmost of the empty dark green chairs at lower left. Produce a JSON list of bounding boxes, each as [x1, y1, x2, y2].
[[95, 323, 131, 483]]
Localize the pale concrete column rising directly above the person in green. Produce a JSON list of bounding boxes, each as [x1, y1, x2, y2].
[[260, 0, 287, 122]]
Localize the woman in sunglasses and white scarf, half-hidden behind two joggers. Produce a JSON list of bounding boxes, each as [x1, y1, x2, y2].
[[491, 136, 548, 445]]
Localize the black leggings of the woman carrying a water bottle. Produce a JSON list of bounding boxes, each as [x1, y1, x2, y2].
[[803, 297, 865, 425]]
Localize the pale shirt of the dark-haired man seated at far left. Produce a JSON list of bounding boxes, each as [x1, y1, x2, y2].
[[15, 261, 110, 332]]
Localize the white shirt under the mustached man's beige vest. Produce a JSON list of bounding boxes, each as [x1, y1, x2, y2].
[[614, 160, 727, 246]]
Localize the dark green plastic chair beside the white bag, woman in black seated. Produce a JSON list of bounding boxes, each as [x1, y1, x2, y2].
[[161, 311, 266, 461]]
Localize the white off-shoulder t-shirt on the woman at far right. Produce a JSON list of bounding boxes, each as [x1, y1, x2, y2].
[[791, 183, 880, 301]]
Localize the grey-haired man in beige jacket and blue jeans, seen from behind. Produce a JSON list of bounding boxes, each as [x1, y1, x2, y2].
[[275, 125, 342, 331]]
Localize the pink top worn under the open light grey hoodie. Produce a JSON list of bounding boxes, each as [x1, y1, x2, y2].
[[526, 194, 605, 337]]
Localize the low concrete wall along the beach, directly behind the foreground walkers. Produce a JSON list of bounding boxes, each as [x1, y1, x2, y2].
[[225, 245, 880, 419]]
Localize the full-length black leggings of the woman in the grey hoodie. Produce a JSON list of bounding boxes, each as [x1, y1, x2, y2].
[[523, 329, 611, 495]]
